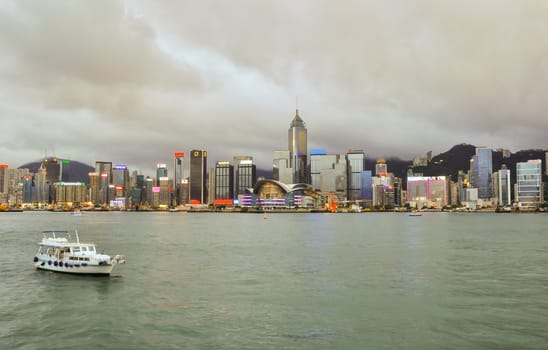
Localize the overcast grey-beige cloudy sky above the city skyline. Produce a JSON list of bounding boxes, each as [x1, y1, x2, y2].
[[0, 0, 548, 175]]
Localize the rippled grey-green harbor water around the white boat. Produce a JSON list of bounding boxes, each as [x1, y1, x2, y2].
[[0, 212, 548, 350]]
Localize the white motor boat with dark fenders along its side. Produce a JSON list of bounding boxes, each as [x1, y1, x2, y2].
[[34, 230, 126, 275]]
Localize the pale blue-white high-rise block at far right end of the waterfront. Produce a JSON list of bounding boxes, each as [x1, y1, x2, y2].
[[516, 159, 543, 210]]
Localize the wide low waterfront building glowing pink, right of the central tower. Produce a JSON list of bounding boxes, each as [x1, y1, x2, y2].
[[407, 176, 449, 209]]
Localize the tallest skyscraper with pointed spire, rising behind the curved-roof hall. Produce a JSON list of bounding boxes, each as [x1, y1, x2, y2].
[[288, 109, 308, 183]]
